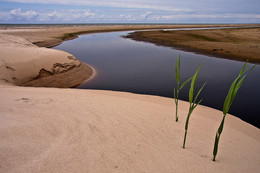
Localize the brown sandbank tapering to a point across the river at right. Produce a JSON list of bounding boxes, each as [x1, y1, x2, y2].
[[126, 27, 260, 64]]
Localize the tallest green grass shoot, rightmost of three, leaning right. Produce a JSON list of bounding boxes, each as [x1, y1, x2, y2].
[[213, 61, 256, 161]]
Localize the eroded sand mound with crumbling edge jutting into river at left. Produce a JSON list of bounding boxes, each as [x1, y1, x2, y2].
[[0, 34, 93, 88]]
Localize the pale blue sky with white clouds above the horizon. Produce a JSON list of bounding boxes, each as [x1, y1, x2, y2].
[[0, 0, 260, 24]]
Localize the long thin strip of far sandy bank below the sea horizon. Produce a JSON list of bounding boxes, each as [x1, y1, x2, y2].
[[0, 24, 255, 47]]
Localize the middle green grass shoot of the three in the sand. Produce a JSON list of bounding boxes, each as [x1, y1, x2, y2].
[[182, 65, 206, 148]]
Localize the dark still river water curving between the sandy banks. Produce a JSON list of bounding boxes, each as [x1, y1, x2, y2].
[[54, 32, 260, 128]]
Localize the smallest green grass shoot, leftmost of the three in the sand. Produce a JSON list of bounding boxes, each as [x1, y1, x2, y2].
[[174, 55, 191, 122]]
